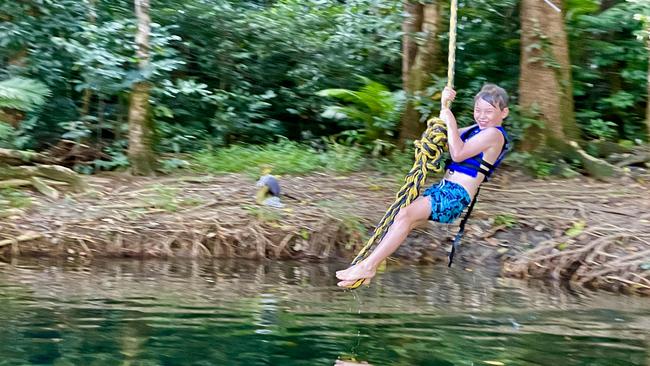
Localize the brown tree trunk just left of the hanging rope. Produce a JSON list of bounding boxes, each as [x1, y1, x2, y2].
[[400, 0, 440, 143]]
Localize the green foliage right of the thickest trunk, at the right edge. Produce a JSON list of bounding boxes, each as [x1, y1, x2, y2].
[[568, 1, 650, 141]]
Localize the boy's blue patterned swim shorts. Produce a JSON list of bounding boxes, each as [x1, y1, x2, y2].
[[422, 179, 472, 224]]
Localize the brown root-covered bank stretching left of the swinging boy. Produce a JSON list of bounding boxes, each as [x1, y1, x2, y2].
[[0, 177, 370, 260]]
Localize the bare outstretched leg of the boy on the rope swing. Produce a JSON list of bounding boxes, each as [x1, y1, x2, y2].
[[336, 196, 431, 286]]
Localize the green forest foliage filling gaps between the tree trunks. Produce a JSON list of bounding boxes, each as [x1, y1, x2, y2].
[[0, 0, 650, 167]]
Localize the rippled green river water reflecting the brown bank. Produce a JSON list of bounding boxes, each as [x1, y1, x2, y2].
[[0, 261, 650, 366]]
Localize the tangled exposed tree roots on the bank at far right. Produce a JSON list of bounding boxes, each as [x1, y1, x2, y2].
[[492, 173, 650, 295]]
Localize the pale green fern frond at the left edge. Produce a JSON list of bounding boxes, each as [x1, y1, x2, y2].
[[0, 77, 50, 112]]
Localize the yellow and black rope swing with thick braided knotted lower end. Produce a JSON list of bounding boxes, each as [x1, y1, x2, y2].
[[349, 0, 458, 289]]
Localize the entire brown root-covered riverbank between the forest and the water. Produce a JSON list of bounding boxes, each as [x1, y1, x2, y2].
[[0, 171, 650, 294]]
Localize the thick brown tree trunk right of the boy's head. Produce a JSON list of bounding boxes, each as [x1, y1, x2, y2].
[[519, 0, 579, 151]]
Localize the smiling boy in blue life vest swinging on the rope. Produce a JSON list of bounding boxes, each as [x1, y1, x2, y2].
[[336, 84, 509, 287]]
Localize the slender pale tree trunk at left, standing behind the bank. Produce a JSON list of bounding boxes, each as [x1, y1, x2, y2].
[[129, 0, 155, 175]]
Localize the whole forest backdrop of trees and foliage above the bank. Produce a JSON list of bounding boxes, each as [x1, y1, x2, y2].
[[0, 0, 650, 176]]
